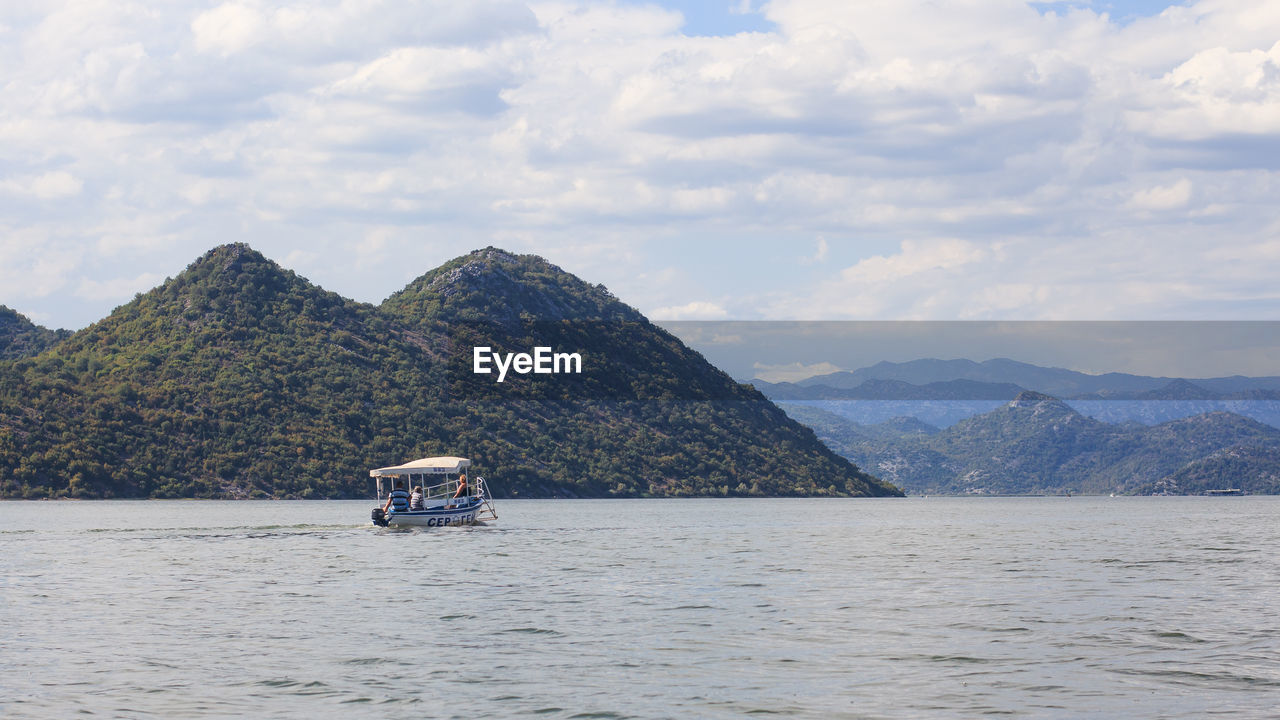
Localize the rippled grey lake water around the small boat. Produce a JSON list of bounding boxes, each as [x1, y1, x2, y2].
[[0, 497, 1280, 719]]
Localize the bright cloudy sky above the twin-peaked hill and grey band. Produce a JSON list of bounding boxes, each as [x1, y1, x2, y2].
[[0, 0, 1280, 328]]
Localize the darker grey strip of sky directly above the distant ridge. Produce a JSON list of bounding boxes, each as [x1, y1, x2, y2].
[[660, 320, 1280, 382]]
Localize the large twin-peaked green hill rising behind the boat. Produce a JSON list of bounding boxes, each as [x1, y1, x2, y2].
[[0, 245, 899, 497]]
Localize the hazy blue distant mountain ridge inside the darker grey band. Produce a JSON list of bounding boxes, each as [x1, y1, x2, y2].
[[753, 359, 1280, 400]]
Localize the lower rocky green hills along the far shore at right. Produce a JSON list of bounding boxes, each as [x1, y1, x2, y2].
[[788, 391, 1280, 495]]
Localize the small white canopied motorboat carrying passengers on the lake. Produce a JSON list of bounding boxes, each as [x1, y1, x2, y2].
[[369, 456, 498, 528]]
